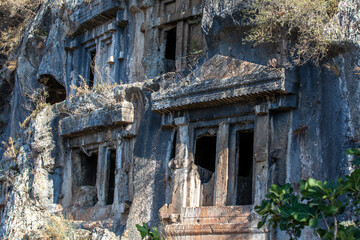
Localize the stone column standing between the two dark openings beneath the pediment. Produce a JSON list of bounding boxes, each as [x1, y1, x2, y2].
[[214, 123, 229, 206]]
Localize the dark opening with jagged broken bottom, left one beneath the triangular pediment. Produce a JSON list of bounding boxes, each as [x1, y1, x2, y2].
[[195, 135, 216, 184]]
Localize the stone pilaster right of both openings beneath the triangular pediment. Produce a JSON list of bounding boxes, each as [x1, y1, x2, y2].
[[253, 104, 270, 205]]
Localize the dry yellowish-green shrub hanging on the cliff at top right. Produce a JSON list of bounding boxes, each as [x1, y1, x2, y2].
[[245, 0, 340, 65]]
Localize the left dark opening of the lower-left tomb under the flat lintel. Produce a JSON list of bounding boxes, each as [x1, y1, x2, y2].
[[80, 152, 98, 186]]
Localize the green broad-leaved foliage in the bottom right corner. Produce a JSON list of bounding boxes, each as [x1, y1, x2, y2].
[[255, 149, 360, 240]]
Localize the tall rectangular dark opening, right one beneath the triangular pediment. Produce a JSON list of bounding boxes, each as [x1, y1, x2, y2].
[[236, 131, 254, 205]]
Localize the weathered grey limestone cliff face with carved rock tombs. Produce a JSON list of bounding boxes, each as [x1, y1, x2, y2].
[[0, 0, 360, 239]]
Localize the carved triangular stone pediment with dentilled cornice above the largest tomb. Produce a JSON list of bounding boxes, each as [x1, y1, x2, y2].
[[152, 55, 296, 113]]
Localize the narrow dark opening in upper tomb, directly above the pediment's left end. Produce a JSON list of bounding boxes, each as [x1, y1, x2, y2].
[[165, 27, 176, 72]]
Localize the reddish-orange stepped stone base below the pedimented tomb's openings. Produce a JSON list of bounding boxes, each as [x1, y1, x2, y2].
[[160, 204, 267, 239]]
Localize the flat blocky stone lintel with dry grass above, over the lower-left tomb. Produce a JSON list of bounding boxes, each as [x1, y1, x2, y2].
[[60, 102, 134, 136]]
